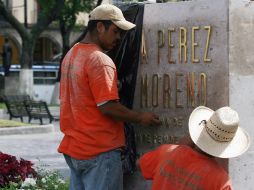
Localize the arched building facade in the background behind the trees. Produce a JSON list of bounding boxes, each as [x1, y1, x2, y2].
[[0, 0, 112, 65]]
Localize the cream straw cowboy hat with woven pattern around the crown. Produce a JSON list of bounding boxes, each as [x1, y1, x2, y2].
[[189, 106, 250, 158]]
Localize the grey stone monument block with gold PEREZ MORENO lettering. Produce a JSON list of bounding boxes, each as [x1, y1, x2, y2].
[[125, 0, 254, 190]]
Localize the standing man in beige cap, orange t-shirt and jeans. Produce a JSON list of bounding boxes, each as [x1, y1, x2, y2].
[[58, 4, 160, 190]]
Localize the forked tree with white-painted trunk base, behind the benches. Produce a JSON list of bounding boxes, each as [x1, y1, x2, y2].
[[0, 0, 65, 95]]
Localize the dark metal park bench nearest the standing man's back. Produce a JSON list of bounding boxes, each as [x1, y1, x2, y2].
[[24, 100, 59, 125]]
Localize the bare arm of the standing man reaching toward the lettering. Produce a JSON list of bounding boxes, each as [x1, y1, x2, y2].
[[99, 101, 161, 126]]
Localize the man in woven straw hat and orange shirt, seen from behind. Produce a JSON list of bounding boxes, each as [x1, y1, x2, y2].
[[137, 106, 250, 190]]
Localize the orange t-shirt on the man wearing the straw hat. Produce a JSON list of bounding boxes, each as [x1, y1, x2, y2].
[[140, 144, 232, 190]]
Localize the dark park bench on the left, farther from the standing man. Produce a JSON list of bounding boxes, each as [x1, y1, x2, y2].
[[3, 95, 30, 122]]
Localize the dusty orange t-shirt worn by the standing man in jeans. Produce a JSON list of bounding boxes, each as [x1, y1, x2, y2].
[[58, 43, 125, 159]]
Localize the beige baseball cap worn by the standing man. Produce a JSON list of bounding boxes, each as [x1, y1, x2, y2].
[[89, 4, 136, 30]]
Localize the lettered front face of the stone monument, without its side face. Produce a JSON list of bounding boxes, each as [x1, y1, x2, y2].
[[126, 0, 229, 190]]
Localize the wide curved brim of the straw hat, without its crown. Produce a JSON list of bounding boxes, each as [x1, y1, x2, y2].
[[189, 106, 250, 158]]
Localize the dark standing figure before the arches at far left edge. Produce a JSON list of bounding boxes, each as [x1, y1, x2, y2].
[[3, 38, 12, 76]]
